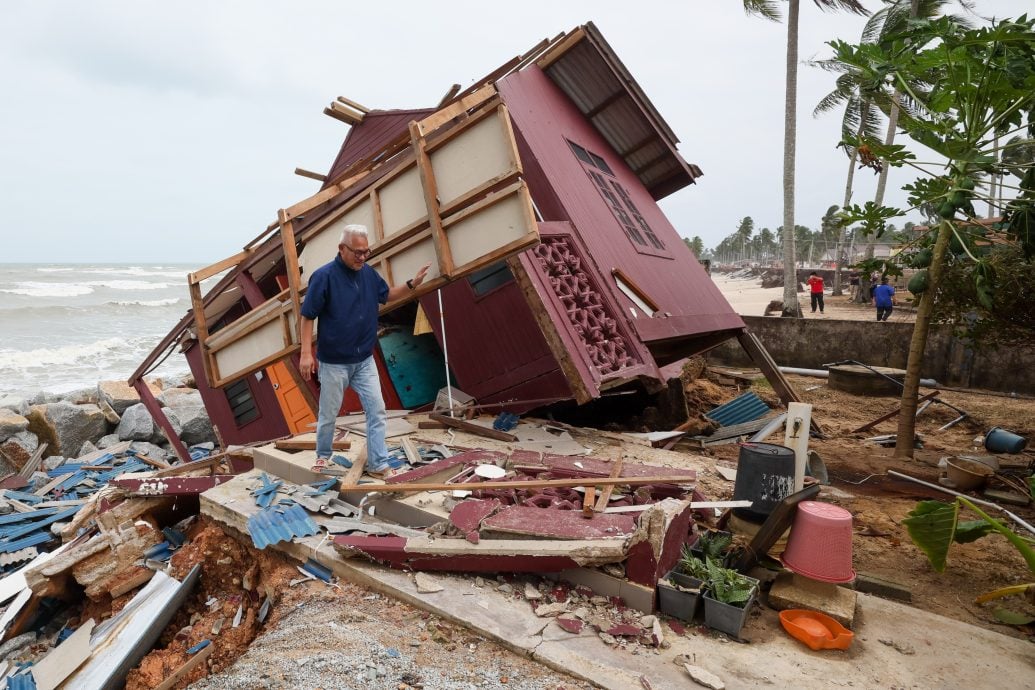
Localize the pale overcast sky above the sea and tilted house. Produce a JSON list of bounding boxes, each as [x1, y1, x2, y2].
[[0, 0, 1030, 266]]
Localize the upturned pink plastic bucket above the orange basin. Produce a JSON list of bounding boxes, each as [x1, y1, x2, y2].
[[780, 501, 855, 583]]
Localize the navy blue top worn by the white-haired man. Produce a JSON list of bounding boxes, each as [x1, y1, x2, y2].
[[302, 256, 388, 364]]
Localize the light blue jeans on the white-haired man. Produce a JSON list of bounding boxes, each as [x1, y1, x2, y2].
[[317, 355, 388, 467]]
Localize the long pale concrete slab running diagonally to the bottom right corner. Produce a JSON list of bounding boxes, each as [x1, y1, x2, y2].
[[201, 471, 1035, 690]]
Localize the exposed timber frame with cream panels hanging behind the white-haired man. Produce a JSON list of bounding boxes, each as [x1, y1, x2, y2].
[[187, 91, 539, 388]]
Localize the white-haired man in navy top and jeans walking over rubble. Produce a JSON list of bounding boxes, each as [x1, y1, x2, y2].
[[299, 226, 430, 474]]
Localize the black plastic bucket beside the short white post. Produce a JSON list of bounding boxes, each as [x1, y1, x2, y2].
[[733, 443, 794, 521]]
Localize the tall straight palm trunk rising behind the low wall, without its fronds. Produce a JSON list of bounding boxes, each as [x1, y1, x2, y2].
[[780, 0, 801, 317]]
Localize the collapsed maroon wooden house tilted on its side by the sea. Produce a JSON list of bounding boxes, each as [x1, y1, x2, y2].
[[129, 24, 743, 457]]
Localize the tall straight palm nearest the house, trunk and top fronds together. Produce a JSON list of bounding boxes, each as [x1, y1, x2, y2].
[[743, 0, 868, 317]]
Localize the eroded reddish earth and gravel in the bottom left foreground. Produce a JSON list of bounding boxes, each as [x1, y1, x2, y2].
[[121, 518, 589, 690]]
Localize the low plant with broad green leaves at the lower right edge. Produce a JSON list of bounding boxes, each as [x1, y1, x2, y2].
[[903, 497, 1035, 622]]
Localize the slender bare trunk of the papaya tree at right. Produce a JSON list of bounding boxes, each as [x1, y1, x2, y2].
[[895, 219, 952, 457]]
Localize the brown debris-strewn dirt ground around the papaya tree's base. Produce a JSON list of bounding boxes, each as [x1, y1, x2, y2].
[[704, 377, 1035, 637]]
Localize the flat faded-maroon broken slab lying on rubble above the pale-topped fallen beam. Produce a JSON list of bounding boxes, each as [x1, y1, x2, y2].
[[481, 506, 637, 541]]
